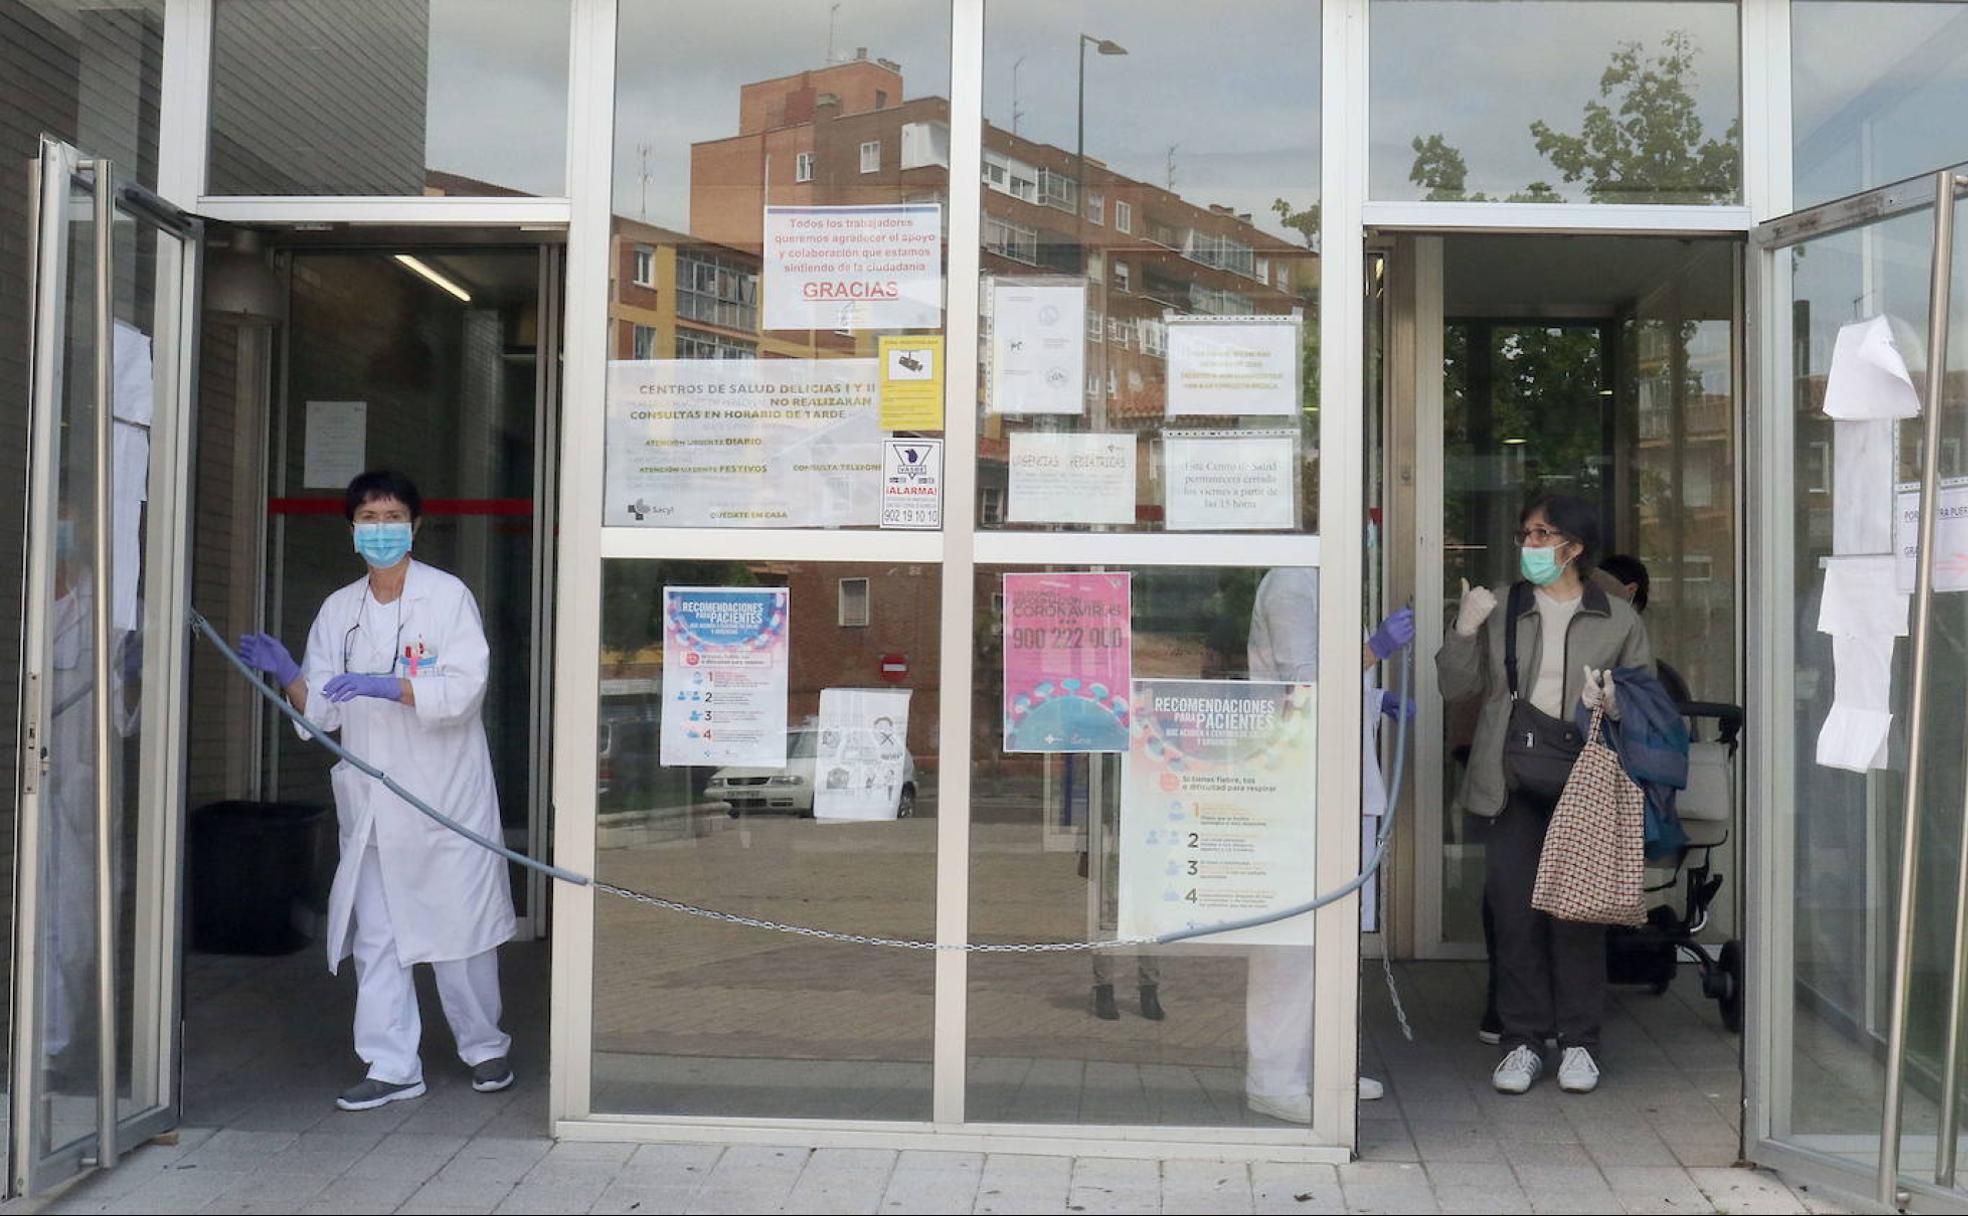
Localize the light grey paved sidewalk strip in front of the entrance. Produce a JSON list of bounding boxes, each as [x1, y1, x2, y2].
[[43, 1125, 1842, 1214]]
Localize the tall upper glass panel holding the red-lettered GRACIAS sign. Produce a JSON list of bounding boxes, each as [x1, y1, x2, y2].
[[602, 0, 951, 527]]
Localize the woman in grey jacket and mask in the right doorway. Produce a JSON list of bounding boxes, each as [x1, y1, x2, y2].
[[1435, 494, 1653, 1094]]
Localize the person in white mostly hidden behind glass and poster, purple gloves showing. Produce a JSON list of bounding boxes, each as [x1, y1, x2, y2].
[[1244, 567, 1415, 1124]]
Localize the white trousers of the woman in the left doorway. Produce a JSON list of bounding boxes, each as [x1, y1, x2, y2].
[[350, 844, 512, 1084]]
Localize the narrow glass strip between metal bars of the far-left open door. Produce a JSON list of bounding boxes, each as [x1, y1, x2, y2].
[[33, 168, 102, 1157]]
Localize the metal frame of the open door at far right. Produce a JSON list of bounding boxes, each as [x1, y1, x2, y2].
[[1744, 165, 1968, 1210]]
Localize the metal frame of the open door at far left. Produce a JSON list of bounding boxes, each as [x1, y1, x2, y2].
[[8, 136, 203, 1194]]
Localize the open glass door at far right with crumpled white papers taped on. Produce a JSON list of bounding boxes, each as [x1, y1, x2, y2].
[[1746, 169, 1968, 1208]]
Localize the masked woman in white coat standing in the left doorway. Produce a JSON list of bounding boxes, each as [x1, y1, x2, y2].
[[240, 472, 514, 1110]]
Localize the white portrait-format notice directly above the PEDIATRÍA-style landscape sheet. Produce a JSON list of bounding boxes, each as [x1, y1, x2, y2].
[[986, 279, 1086, 413]]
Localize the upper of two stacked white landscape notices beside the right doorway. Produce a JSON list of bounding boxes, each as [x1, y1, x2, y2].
[[1169, 315, 1303, 417]]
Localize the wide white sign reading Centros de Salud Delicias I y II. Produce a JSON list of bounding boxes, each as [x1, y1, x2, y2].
[[602, 358, 882, 527]]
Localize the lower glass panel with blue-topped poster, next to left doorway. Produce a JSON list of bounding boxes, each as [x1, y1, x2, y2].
[[594, 561, 943, 1120]]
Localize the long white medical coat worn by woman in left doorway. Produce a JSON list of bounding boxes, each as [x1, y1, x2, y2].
[[301, 561, 514, 972]]
